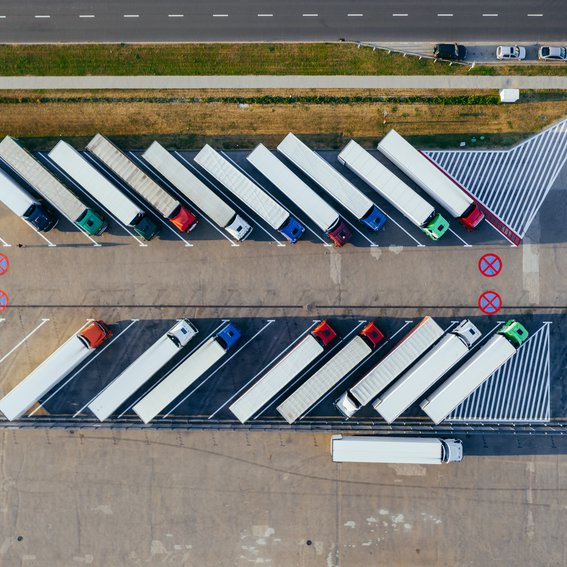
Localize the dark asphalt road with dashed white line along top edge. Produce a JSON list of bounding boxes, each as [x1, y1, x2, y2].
[[0, 0, 567, 43]]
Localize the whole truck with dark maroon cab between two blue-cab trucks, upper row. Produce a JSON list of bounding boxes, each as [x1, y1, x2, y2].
[[246, 144, 352, 247]]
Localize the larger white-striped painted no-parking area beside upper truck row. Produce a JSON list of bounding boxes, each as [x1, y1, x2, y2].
[[424, 119, 567, 238]]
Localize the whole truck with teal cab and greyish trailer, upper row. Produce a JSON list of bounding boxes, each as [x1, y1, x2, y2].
[[0, 136, 108, 236]]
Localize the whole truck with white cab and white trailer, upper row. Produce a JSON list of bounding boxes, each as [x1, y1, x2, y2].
[[142, 142, 252, 240]]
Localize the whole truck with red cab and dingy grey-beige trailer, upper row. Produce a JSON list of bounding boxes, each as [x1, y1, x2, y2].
[[87, 134, 197, 232]]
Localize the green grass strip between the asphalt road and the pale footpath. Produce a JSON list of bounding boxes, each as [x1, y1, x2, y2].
[[0, 43, 567, 76]]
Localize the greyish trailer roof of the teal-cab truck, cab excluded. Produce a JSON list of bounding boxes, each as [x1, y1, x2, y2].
[[0, 136, 87, 221]]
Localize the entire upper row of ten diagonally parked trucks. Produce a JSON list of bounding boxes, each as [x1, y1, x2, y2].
[[0, 130, 484, 246]]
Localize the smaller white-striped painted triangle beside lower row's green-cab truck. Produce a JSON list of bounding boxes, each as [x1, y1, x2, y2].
[[447, 323, 551, 422]]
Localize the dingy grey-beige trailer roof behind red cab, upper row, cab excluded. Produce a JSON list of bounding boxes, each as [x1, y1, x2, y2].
[[87, 134, 180, 218]]
